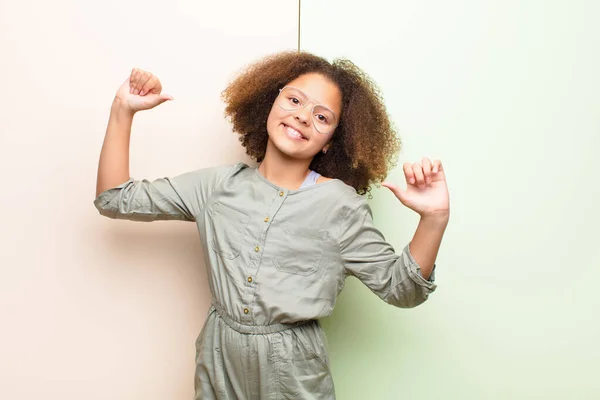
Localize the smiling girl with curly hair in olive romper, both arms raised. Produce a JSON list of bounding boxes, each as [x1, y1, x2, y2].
[[95, 52, 449, 399]]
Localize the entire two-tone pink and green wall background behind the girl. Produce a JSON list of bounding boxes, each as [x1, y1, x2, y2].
[[0, 0, 600, 400]]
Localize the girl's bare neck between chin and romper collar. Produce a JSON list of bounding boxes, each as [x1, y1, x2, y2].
[[258, 140, 312, 190]]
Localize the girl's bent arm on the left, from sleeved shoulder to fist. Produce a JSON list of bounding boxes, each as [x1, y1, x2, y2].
[[94, 69, 239, 222]]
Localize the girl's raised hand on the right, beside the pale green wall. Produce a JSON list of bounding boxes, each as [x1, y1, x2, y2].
[[382, 158, 450, 218]]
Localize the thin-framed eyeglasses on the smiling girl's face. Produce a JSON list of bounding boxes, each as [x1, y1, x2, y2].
[[277, 86, 338, 135]]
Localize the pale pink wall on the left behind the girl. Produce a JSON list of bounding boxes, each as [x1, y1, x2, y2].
[[0, 0, 298, 400]]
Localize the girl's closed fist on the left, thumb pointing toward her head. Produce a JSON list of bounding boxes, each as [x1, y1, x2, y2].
[[116, 68, 173, 113]]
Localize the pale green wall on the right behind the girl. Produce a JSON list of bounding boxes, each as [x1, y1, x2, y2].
[[301, 0, 600, 400]]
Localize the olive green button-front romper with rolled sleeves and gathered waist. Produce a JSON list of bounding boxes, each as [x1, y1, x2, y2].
[[94, 163, 436, 400]]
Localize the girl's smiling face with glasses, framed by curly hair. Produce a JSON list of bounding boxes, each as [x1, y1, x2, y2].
[[267, 73, 342, 159]]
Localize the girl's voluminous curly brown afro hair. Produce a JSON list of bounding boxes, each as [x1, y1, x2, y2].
[[222, 51, 401, 195]]
